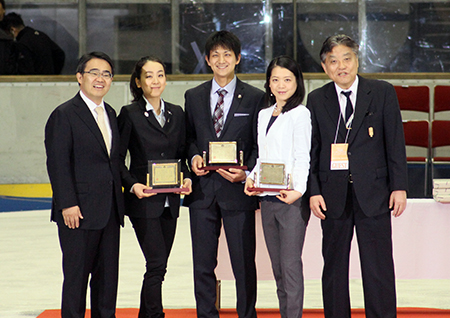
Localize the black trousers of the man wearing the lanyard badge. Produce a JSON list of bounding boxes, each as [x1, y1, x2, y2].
[[322, 183, 397, 318]]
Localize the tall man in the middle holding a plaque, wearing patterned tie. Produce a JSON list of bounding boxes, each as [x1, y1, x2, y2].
[[184, 31, 264, 318]]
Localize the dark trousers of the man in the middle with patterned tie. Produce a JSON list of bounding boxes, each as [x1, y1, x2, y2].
[[189, 202, 256, 318]]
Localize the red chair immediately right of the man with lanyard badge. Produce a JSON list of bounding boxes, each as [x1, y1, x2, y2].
[[403, 120, 431, 198]]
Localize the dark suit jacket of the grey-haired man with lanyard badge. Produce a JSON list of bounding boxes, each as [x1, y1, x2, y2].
[[307, 77, 407, 218]]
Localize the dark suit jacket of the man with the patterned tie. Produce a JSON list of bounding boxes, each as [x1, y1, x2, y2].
[[184, 79, 264, 210]]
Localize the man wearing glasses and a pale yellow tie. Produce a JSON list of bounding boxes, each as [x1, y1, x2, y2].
[[45, 52, 124, 318]]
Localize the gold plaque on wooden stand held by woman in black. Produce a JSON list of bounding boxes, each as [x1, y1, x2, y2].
[[144, 159, 189, 193]]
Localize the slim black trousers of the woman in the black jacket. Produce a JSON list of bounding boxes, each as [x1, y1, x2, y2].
[[130, 208, 177, 318]]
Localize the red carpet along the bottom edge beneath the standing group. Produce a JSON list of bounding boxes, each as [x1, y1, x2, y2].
[[37, 308, 450, 318]]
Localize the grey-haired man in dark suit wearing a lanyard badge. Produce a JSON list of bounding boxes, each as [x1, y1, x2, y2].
[[307, 35, 408, 318]]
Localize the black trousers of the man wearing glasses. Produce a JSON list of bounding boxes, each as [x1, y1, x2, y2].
[[58, 210, 120, 318]]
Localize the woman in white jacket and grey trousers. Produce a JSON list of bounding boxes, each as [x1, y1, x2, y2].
[[244, 56, 311, 318]]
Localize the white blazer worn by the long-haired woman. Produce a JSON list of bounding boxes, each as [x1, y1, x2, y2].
[[249, 104, 312, 196]]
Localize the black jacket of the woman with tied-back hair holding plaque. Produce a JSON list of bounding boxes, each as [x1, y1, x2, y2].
[[118, 98, 190, 218]]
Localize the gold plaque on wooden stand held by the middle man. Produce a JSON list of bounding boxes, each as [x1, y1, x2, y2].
[[200, 141, 247, 170]]
